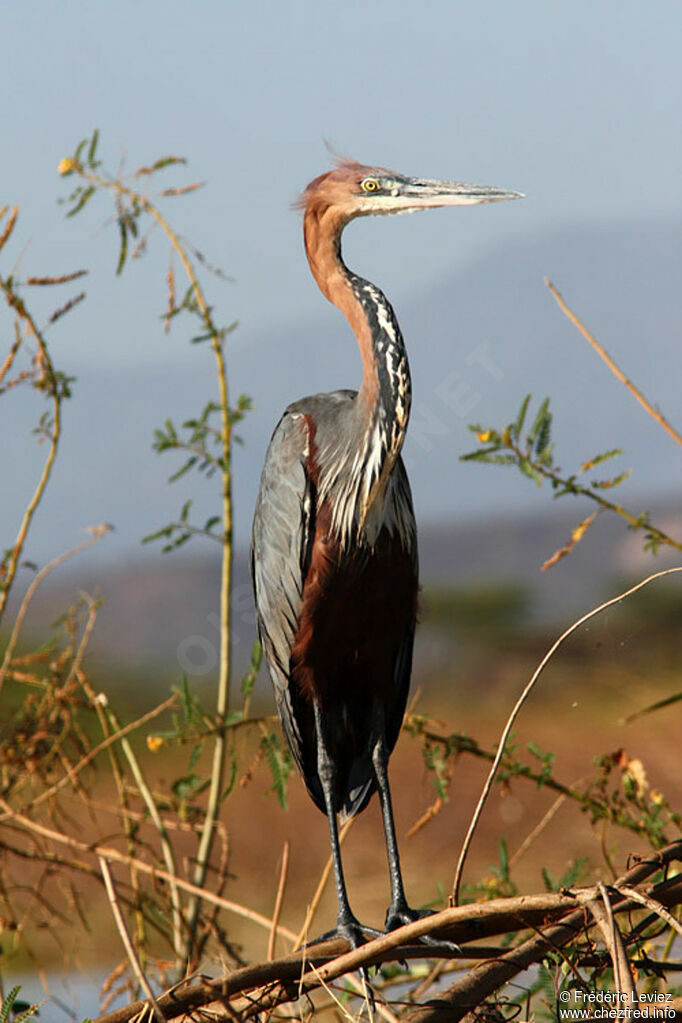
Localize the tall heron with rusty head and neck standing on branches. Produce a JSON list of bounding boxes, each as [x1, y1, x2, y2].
[[252, 160, 520, 948]]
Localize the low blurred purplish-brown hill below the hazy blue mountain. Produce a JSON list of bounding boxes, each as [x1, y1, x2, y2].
[[7, 495, 682, 684]]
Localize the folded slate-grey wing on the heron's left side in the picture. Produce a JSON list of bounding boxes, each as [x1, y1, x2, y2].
[[252, 409, 315, 772]]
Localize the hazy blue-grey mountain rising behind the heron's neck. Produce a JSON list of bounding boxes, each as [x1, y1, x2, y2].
[[0, 220, 682, 562]]
